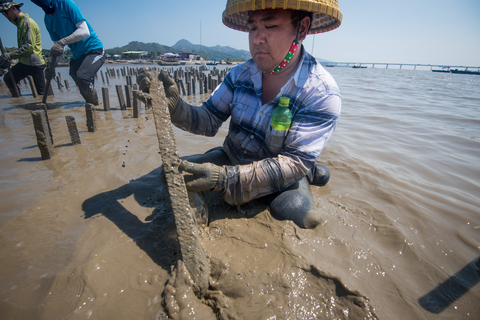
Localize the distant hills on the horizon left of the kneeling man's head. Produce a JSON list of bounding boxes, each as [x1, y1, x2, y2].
[[105, 39, 251, 60]]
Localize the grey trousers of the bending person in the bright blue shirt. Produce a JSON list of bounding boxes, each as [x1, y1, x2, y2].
[[69, 48, 105, 105]]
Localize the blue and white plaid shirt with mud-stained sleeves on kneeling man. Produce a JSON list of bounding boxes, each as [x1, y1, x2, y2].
[[172, 48, 341, 204]]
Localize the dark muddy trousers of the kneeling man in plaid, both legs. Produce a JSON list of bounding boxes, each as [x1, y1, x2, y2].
[[182, 147, 330, 229]]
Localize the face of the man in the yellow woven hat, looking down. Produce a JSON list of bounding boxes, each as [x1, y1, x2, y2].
[[248, 9, 297, 72]]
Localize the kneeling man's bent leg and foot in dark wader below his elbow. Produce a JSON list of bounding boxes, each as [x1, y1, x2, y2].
[[263, 164, 330, 229]]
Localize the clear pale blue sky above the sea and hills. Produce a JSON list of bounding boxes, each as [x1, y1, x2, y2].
[[0, 0, 480, 67]]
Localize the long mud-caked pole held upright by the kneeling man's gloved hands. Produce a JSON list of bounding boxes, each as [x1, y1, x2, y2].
[[150, 75, 209, 298]]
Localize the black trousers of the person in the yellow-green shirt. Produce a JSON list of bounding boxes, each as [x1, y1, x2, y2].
[[3, 62, 45, 96]]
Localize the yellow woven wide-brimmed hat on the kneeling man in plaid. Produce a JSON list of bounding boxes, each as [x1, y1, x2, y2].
[[222, 0, 343, 34]]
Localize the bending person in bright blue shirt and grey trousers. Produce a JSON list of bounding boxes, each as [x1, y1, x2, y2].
[[32, 0, 105, 105]]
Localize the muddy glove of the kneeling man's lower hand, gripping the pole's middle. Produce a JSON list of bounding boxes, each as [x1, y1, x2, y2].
[[178, 160, 227, 192]]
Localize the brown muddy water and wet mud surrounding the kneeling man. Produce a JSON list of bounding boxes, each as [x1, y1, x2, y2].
[[0, 65, 480, 319]]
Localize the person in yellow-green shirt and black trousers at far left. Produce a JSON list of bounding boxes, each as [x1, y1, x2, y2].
[[0, 0, 45, 95]]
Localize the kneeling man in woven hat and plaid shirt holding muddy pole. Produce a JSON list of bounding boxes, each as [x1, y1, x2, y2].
[[137, 0, 342, 228]]
